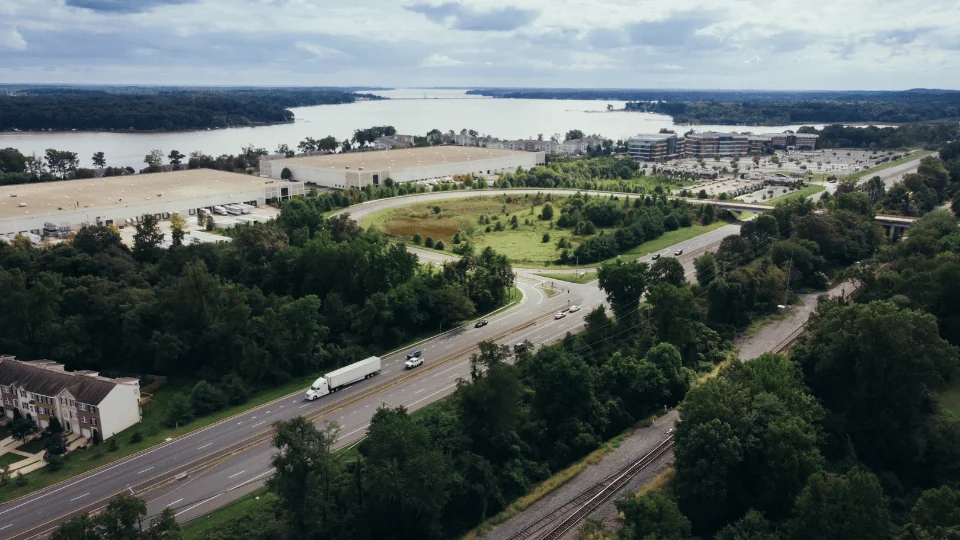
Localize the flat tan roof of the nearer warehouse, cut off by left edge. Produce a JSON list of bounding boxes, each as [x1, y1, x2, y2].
[[0, 169, 278, 218]]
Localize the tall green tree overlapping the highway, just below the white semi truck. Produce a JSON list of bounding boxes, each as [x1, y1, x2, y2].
[[268, 417, 348, 538]]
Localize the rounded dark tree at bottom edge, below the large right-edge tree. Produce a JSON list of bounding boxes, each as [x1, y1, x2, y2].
[[787, 468, 891, 540]]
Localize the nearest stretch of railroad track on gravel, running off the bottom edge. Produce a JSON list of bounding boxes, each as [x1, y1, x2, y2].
[[509, 435, 673, 540]]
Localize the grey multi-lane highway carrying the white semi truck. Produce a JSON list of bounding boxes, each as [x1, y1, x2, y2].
[[0, 190, 738, 540]]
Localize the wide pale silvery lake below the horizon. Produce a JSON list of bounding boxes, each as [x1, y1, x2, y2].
[[0, 89, 824, 169]]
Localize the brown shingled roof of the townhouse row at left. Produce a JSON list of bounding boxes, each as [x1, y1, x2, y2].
[[0, 357, 123, 405]]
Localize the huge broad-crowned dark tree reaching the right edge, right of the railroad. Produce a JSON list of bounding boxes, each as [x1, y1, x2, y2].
[[792, 302, 960, 474]]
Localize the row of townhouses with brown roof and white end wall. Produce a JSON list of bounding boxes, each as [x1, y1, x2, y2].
[[0, 356, 140, 440]]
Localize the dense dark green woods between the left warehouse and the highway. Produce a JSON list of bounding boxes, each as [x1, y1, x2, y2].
[[0, 197, 513, 414]]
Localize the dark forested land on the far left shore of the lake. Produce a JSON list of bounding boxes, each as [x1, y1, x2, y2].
[[0, 88, 380, 131]]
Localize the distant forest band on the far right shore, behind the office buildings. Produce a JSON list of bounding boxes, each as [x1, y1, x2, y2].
[[626, 99, 960, 126]]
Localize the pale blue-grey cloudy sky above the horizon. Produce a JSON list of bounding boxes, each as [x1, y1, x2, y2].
[[0, 0, 960, 89]]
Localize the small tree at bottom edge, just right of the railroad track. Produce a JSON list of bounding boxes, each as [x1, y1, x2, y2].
[[616, 491, 691, 540]]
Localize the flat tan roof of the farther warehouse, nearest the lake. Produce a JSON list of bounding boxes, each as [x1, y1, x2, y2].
[[262, 146, 531, 170]]
